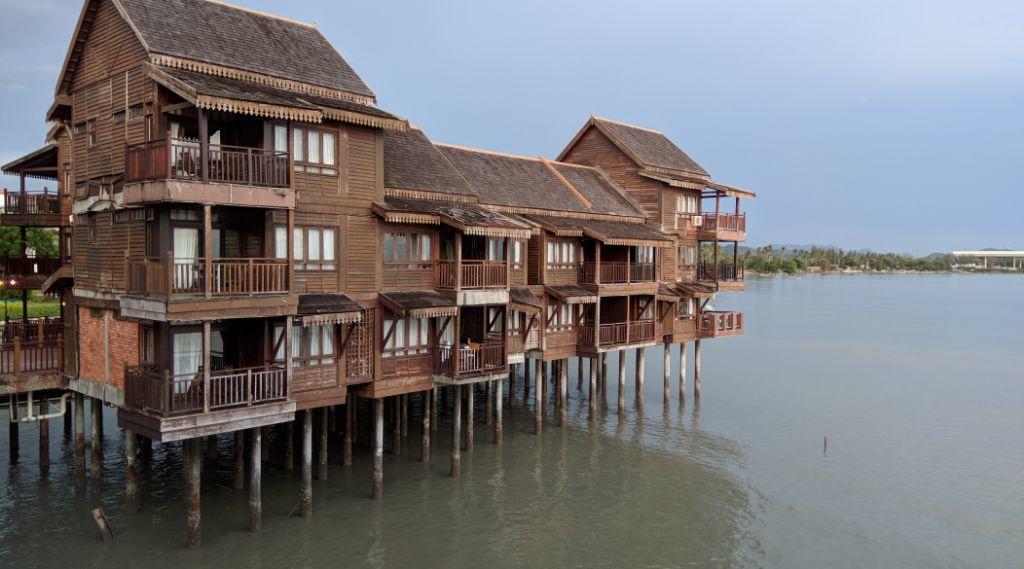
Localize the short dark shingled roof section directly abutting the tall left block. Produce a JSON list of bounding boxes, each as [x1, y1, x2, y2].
[[384, 127, 476, 201]]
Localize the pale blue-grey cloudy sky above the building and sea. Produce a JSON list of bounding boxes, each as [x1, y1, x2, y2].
[[0, 0, 1024, 255]]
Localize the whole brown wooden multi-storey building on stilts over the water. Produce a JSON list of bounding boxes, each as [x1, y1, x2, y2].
[[0, 0, 753, 546]]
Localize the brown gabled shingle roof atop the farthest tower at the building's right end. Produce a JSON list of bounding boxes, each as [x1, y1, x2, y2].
[[558, 117, 710, 178]]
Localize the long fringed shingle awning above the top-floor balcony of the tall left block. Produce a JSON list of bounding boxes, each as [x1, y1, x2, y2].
[[145, 63, 409, 130]]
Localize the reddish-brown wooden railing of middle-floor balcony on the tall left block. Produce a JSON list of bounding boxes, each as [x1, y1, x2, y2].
[[125, 256, 288, 296]]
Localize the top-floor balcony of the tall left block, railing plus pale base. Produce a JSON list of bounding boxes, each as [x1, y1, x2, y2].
[[124, 136, 295, 208]]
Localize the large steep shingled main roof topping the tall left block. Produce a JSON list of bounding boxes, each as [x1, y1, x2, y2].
[[119, 0, 375, 98]]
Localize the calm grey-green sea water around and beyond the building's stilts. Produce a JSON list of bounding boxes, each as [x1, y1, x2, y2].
[[0, 275, 1024, 569]]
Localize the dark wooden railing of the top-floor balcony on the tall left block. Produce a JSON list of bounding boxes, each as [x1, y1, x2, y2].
[[125, 135, 290, 187]]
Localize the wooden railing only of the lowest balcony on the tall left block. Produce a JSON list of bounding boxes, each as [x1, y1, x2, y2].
[[125, 365, 288, 417]]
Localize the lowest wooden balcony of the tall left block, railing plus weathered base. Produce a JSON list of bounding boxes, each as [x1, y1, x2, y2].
[[118, 365, 295, 441]]
